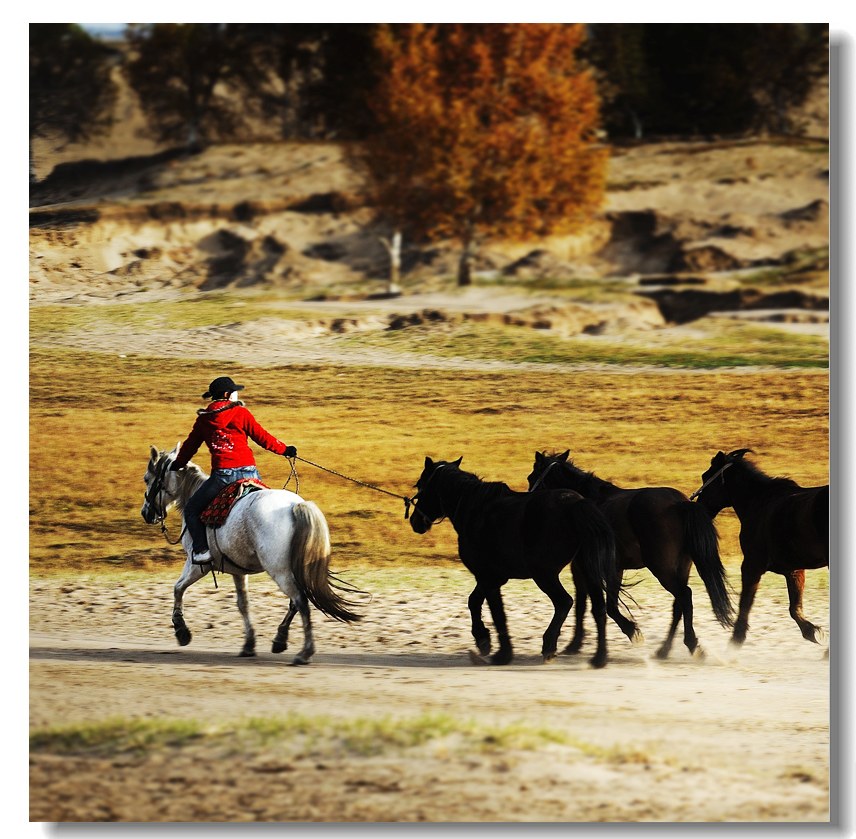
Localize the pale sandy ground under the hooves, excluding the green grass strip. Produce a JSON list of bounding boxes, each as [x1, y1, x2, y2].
[[30, 561, 830, 823]]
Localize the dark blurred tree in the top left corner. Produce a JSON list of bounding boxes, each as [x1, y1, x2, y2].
[[30, 23, 117, 148]]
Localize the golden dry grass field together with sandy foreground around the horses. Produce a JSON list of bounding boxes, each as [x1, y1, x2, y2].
[[30, 326, 829, 822]]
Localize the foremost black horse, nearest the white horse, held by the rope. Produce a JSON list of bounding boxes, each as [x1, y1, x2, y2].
[[410, 457, 621, 667]]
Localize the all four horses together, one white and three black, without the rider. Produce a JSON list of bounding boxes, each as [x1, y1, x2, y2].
[[140, 445, 829, 667]]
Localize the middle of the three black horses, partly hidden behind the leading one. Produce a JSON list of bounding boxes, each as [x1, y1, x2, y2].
[[529, 451, 734, 658]]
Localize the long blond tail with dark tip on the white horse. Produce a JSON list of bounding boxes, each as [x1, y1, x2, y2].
[[291, 501, 362, 623]]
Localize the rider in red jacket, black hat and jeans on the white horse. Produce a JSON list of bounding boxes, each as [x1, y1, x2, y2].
[[170, 376, 297, 565]]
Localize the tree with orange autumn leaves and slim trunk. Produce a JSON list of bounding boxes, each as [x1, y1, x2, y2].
[[362, 23, 607, 285]]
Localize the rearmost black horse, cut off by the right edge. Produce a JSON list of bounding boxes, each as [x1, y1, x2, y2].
[[693, 449, 829, 644]]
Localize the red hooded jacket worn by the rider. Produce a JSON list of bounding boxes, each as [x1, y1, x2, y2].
[[175, 399, 285, 469]]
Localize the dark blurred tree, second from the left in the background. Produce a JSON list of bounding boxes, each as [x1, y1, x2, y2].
[[127, 23, 268, 146]]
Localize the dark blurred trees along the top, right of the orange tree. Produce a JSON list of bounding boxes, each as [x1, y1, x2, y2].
[[587, 23, 829, 136]]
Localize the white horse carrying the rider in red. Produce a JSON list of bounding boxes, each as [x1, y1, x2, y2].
[[140, 444, 360, 664]]
